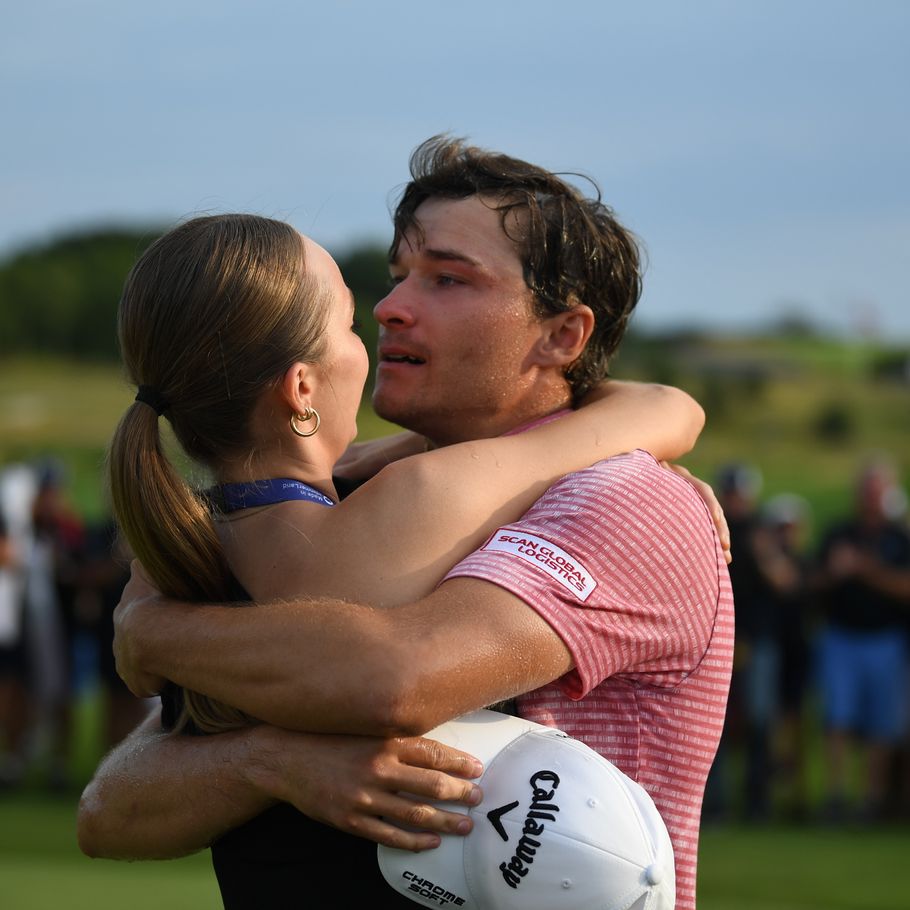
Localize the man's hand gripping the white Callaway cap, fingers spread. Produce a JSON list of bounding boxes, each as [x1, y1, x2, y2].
[[247, 727, 483, 851]]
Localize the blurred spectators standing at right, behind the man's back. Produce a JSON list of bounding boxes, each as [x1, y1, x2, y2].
[[705, 459, 910, 824]]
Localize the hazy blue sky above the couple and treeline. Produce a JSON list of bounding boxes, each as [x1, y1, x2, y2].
[[0, 0, 910, 344]]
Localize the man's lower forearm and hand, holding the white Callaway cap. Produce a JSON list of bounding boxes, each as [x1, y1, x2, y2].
[[78, 713, 482, 859]]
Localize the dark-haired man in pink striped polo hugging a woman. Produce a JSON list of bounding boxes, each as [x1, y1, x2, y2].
[[81, 139, 732, 908]]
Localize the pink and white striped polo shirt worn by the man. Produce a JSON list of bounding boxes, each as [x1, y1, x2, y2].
[[447, 451, 733, 910]]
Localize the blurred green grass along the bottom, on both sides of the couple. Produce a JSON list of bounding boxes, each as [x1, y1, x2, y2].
[[0, 792, 910, 910]]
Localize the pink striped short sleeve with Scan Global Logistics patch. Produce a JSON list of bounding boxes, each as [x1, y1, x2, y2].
[[446, 451, 726, 698]]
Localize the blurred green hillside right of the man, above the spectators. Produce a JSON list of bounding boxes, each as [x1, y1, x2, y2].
[[615, 327, 910, 530]]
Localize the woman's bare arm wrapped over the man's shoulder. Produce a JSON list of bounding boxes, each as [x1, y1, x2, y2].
[[256, 382, 704, 605]]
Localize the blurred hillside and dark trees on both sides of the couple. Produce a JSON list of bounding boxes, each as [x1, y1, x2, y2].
[[0, 228, 910, 536]]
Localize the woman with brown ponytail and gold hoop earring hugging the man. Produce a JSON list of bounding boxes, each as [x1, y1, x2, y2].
[[110, 215, 702, 904]]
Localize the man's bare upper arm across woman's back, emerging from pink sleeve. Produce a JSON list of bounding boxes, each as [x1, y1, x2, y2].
[[114, 570, 572, 736]]
